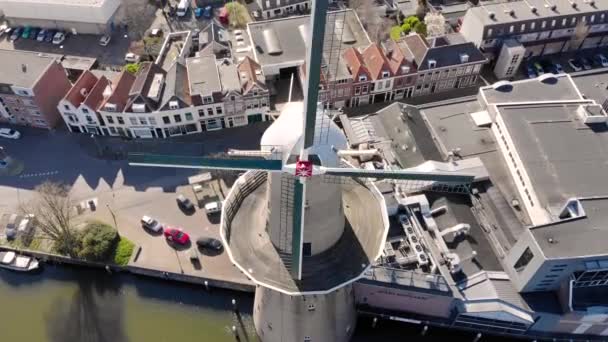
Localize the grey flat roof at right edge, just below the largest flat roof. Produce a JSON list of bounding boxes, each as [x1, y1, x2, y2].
[[530, 198, 608, 258]]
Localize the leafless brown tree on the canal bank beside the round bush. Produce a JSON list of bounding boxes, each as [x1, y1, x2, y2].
[[21, 182, 79, 256]]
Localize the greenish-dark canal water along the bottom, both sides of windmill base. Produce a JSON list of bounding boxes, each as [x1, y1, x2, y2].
[[0, 265, 524, 342]]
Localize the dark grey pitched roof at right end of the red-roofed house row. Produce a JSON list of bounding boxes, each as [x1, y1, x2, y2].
[[418, 43, 486, 71]]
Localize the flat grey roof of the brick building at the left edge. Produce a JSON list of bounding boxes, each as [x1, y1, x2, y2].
[[0, 50, 61, 88]]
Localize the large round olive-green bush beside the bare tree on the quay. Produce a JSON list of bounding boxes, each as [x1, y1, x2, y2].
[[78, 221, 118, 261]]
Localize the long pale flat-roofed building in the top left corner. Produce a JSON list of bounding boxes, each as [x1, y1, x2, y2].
[[0, 0, 122, 34]]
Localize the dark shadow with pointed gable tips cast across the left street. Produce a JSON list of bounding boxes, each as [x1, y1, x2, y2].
[[0, 122, 270, 192]]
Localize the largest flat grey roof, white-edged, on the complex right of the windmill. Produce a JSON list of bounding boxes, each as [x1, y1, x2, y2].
[[498, 103, 608, 207]]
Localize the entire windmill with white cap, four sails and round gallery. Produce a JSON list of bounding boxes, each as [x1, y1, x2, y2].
[[129, 0, 473, 342]]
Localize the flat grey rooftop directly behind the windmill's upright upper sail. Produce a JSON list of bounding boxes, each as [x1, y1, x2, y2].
[[247, 10, 371, 72]]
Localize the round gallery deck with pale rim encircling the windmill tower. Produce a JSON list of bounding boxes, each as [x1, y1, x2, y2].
[[221, 171, 388, 294]]
